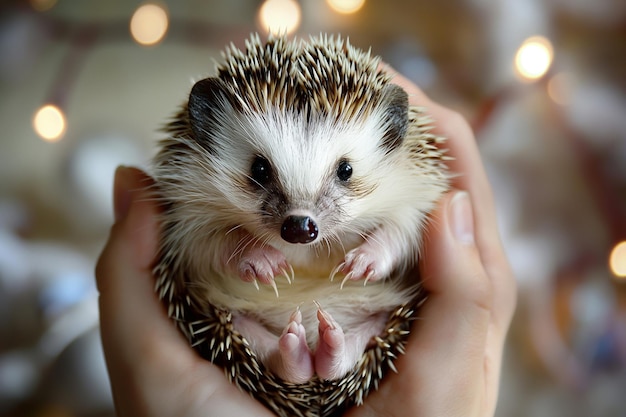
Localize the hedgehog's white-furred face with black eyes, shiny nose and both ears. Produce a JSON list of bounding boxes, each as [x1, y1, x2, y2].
[[188, 74, 408, 254]]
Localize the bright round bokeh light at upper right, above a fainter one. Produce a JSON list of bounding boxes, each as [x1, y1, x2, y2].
[[515, 36, 554, 81]]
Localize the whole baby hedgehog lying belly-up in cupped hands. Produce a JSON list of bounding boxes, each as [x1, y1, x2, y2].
[[153, 35, 448, 416]]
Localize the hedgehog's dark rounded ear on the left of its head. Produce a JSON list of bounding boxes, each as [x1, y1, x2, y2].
[[187, 77, 234, 145]]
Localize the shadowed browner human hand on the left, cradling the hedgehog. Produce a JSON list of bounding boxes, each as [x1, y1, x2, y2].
[[96, 168, 272, 417]]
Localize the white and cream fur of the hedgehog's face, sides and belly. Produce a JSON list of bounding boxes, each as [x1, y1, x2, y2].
[[155, 103, 446, 344]]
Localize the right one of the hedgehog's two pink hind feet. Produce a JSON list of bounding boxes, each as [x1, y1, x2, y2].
[[315, 306, 354, 380]]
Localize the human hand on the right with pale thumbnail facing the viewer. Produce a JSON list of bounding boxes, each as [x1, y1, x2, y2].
[[346, 69, 517, 417]]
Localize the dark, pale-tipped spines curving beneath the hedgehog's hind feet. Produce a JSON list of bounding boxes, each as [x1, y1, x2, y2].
[[158, 264, 425, 417]]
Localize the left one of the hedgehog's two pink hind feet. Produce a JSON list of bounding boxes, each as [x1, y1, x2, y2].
[[272, 309, 314, 384]]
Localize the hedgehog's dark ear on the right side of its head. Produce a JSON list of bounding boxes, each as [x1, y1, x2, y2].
[[382, 84, 409, 152]]
